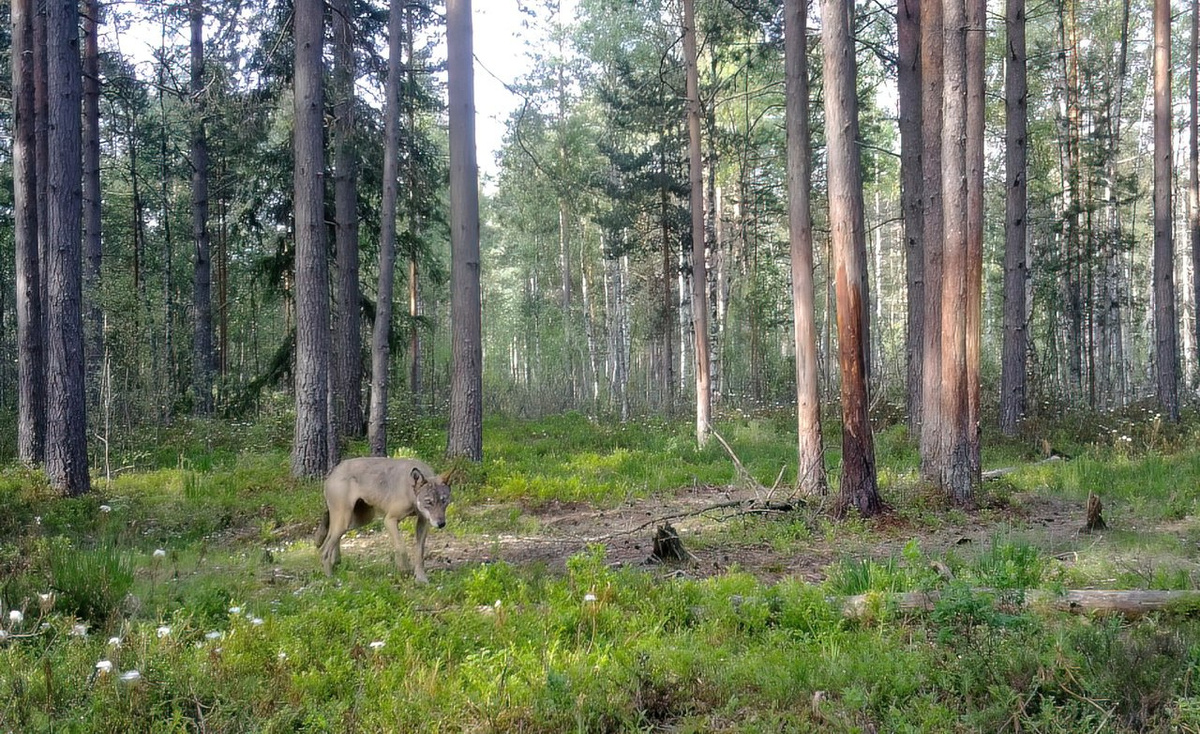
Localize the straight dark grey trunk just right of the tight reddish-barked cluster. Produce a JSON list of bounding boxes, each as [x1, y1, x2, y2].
[[1000, 0, 1028, 435]]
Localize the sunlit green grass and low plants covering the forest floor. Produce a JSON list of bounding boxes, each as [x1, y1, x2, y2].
[[0, 415, 1200, 732]]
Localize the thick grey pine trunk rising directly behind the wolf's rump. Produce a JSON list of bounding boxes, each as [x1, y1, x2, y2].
[[292, 0, 331, 476]]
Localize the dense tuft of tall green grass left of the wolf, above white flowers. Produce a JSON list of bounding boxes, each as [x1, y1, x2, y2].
[[50, 545, 133, 622]]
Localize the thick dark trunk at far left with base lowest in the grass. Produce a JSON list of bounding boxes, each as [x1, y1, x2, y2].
[[46, 0, 90, 497]]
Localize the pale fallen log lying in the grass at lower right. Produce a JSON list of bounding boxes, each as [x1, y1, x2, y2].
[[841, 589, 1200, 619]]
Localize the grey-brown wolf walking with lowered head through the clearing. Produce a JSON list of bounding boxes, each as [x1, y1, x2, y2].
[[316, 457, 450, 584]]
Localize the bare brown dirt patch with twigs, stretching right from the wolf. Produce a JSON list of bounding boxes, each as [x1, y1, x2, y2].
[[342, 486, 1091, 582]]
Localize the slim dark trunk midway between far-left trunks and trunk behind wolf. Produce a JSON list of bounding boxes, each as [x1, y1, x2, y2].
[[188, 0, 216, 415]]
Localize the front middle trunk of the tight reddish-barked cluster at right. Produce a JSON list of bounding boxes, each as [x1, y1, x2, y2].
[[926, 0, 974, 505]]
